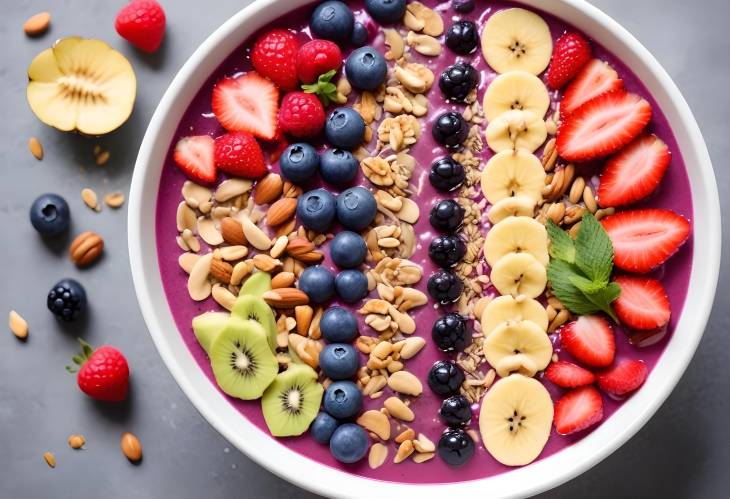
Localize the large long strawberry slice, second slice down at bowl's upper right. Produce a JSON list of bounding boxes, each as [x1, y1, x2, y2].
[[557, 91, 651, 161]]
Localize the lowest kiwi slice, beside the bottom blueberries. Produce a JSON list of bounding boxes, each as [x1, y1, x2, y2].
[[261, 364, 324, 437]]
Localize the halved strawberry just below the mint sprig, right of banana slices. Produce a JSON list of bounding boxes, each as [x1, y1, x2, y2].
[[560, 315, 616, 367]]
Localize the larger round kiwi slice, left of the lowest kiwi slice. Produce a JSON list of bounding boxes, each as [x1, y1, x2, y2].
[[208, 317, 279, 400]]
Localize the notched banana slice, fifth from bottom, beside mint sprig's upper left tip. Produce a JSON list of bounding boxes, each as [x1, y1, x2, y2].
[[484, 217, 550, 266]]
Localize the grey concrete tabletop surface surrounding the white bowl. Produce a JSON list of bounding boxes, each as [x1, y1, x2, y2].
[[0, 0, 730, 499]]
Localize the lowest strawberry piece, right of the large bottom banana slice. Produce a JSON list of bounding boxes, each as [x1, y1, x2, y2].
[[553, 386, 603, 435]]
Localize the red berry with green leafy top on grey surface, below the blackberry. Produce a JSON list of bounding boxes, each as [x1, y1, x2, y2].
[[66, 338, 129, 402]]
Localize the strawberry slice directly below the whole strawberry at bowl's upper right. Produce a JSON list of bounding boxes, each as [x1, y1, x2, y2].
[[560, 59, 624, 118]]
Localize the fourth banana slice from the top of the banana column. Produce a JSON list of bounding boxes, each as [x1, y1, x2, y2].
[[482, 149, 545, 206]]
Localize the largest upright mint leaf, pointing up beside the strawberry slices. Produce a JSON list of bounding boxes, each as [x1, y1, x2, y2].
[[575, 213, 613, 286]]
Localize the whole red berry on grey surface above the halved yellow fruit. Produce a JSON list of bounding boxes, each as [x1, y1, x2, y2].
[[114, 0, 165, 52]]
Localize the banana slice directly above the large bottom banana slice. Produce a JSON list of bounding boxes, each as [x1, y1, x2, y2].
[[483, 321, 553, 377]]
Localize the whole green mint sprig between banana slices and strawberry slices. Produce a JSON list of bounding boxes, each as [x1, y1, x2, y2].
[[547, 213, 621, 321]]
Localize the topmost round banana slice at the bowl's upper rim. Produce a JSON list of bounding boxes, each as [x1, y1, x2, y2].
[[482, 8, 553, 75]]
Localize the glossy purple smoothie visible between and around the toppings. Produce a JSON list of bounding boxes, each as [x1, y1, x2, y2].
[[156, 1, 693, 483]]
